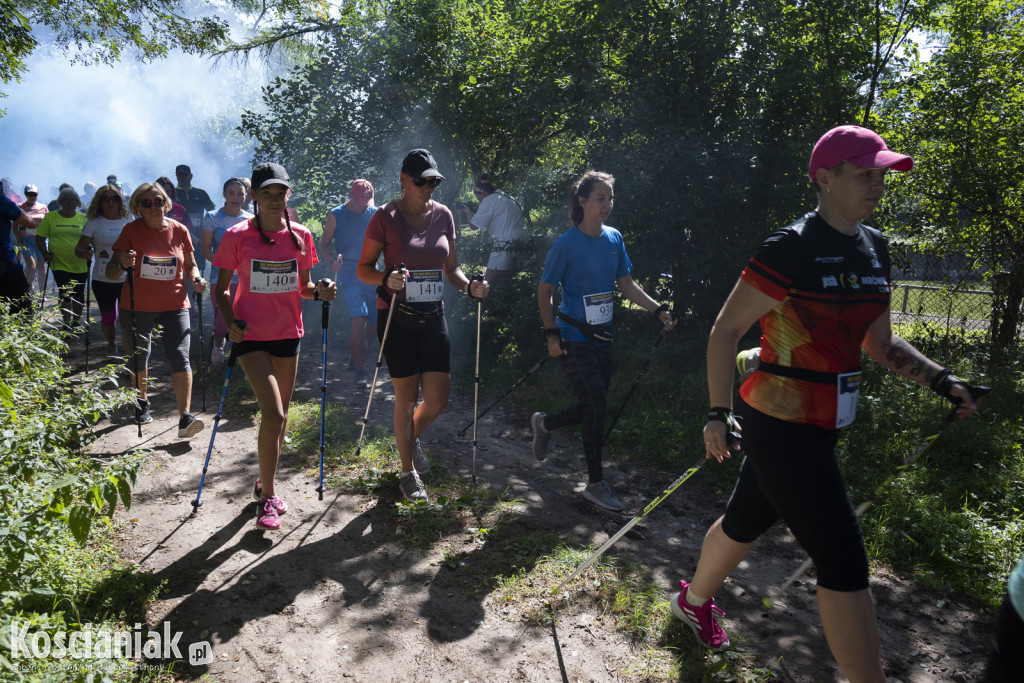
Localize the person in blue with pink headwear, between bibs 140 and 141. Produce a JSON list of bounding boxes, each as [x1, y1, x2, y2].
[[319, 178, 377, 387]]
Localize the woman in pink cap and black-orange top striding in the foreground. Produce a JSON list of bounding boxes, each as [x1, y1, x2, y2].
[[671, 126, 978, 682]]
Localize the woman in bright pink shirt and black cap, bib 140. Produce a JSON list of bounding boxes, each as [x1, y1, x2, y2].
[[213, 164, 338, 529]]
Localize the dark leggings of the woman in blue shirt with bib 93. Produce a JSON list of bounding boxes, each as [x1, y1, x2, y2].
[[544, 342, 611, 483]]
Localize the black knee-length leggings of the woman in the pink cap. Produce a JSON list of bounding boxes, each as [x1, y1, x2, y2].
[[722, 401, 868, 592]]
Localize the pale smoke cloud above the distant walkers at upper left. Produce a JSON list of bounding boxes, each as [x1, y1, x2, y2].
[[0, 46, 265, 204]]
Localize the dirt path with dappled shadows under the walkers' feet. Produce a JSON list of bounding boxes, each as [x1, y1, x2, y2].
[[86, 311, 991, 682]]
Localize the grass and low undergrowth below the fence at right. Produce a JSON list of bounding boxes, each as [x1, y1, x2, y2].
[[839, 329, 1024, 607]]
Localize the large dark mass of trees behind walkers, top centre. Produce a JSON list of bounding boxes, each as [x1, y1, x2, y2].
[[242, 0, 933, 325]]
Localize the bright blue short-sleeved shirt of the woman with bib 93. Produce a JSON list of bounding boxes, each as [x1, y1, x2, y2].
[[541, 225, 633, 341]]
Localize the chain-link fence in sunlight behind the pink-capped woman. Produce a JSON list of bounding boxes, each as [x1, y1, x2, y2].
[[892, 283, 992, 333]]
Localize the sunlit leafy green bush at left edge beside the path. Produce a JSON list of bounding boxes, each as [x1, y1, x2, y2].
[[0, 311, 140, 596]]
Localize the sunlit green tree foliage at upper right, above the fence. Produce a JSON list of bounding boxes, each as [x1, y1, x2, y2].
[[885, 0, 1024, 347]]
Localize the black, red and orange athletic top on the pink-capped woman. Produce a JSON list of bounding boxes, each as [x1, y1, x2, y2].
[[740, 212, 891, 429]]
